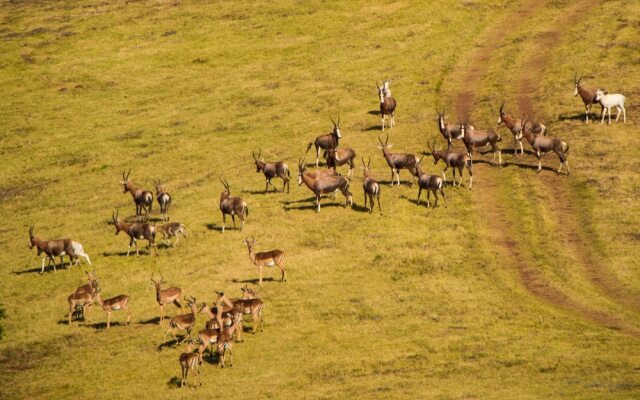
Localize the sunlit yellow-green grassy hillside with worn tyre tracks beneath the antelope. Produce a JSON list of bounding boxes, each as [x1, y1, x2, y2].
[[0, 1, 640, 399]]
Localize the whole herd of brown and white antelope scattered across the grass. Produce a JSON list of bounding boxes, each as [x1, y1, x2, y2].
[[29, 74, 626, 386]]
